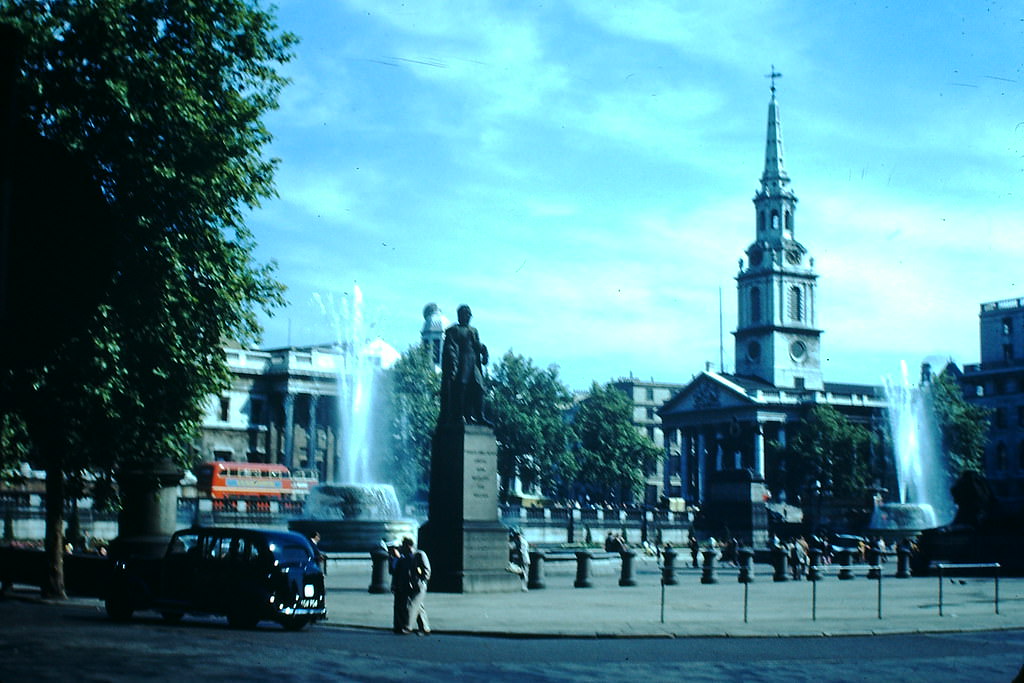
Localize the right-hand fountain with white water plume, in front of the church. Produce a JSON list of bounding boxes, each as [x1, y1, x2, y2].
[[868, 362, 955, 538]]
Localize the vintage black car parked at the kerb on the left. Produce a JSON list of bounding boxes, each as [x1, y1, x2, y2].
[[105, 527, 327, 630]]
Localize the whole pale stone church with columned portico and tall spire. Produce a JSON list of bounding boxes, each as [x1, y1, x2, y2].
[[658, 81, 886, 505]]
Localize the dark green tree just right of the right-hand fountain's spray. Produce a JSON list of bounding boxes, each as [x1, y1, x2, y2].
[[931, 369, 991, 481]]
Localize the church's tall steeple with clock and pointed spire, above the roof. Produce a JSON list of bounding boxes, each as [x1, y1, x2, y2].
[[733, 70, 824, 390]]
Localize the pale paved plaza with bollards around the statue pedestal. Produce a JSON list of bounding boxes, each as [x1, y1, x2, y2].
[[327, 557, 1024, 637]]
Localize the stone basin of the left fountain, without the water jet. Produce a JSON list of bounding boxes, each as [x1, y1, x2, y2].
[[288, 483, 419, 553]]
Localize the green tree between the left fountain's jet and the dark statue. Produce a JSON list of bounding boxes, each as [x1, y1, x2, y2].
[[385, 344, 441, 501]]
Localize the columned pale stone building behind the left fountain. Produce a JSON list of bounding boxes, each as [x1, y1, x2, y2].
[[197, 340, 398, 481]]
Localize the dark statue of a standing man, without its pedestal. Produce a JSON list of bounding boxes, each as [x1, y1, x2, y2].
[[441, 304, 490, 426]]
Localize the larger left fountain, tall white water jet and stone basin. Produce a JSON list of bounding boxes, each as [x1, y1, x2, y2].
[[288, 286, 417, 552]]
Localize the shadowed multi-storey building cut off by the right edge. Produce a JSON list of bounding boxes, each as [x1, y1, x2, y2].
[[961, 298, 1024, 514]]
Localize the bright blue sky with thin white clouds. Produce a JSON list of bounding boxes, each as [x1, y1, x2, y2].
[[249, 0, 1024, 390]]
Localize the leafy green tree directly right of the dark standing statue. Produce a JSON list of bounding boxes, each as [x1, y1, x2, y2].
[[488, 350, 572, 500]]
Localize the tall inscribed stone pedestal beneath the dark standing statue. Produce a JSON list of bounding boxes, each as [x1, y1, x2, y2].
[[419, 424, 522, 593]]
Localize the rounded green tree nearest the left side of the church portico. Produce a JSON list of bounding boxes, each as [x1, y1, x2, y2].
[[572, 382, 662, 503]]
